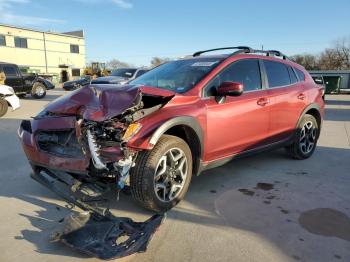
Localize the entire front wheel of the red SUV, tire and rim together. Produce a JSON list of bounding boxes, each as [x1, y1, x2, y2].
[[130, 135, 192, 212]]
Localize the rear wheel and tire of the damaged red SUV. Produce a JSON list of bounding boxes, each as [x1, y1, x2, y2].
[[285, 114, 320, 160]]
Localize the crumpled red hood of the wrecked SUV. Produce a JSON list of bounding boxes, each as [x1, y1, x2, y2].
[[45, 85, 175, 122]]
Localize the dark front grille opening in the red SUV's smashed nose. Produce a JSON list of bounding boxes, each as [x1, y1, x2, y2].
[[36, 129, 84, 158]]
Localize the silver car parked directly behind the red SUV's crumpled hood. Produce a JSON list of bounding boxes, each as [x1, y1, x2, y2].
[[91, 68, 148, 85]]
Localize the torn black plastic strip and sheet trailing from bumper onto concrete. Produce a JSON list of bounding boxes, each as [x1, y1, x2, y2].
[[31, 171, 165, 260]]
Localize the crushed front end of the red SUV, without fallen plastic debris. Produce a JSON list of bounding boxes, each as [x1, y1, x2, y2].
[[18, 86, 173, 196]]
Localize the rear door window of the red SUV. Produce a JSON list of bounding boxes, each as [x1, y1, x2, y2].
[[264, 60, 291, 88]]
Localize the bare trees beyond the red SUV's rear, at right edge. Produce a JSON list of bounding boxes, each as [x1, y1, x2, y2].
[[291, 37, 350, 70]]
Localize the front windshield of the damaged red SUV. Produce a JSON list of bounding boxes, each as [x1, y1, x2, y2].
[[130, 58, 221, 93]]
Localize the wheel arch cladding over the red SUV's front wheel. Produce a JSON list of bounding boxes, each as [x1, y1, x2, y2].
[[150, 116, 203, 174]]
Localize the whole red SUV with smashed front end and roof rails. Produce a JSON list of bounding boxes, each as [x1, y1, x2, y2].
[[18, 46, 324, 212]]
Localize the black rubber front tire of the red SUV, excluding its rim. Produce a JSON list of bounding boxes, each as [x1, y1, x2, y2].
[[130, 135, 192, 212]]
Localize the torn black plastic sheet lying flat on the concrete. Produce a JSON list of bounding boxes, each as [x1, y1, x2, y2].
[[53, 212, 163, 259]]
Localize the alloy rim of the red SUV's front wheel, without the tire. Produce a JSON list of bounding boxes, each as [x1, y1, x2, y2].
[[154, 148, 188, 202]]
